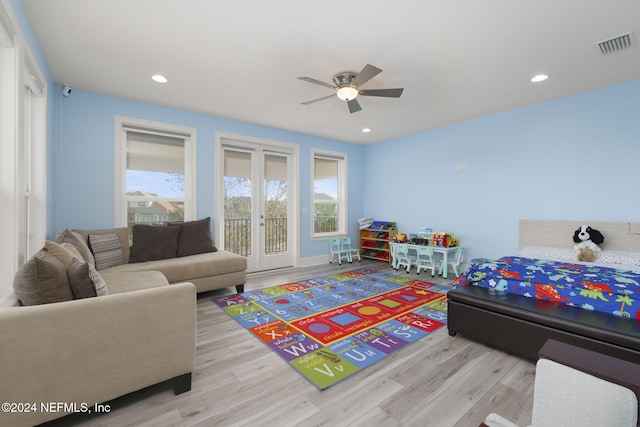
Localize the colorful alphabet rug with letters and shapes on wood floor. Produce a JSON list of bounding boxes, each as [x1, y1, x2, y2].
[[213, 269, 447, 390]]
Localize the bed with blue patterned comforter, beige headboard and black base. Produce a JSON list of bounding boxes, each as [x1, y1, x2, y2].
[[448, 220, 640, 363]]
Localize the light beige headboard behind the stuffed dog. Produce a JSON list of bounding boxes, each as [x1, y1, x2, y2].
[[520, 219, 640, 252]]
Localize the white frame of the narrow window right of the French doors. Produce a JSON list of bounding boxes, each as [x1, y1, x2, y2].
[[310, 148, 349, 240]]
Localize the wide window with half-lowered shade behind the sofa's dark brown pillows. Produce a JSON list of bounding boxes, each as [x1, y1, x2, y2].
[[115, 118, 196, 227]]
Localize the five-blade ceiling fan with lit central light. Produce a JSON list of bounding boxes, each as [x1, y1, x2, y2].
[[298, 64, 404, 113]]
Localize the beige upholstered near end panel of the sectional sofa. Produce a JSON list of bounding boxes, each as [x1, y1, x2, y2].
[[0, 283, 196, 425]]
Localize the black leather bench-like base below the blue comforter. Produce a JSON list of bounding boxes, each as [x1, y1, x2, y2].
[[447, 286, 640, 363]]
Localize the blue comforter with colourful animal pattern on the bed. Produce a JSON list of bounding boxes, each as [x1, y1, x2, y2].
[[454, 256, 640, 320]]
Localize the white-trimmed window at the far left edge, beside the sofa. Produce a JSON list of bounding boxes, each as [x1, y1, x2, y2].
[[0, 0, 49, 299]]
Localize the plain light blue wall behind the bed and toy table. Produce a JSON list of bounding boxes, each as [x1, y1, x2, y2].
[[364, 80, 640, 259]]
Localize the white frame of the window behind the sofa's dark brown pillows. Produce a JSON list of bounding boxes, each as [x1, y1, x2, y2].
[[113, 116, 197, 227]]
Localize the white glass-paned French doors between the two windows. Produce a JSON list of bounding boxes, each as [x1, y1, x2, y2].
[[216, 137, 298, 272]]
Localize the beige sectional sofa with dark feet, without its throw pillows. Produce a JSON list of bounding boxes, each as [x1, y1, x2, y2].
[[0, 222, 246, 426]]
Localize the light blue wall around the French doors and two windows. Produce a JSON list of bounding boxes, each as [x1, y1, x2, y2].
[[54, 88, 364, 258]]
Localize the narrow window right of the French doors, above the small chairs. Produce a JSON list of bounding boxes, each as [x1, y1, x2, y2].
[[312, 150, 347, 237]]
